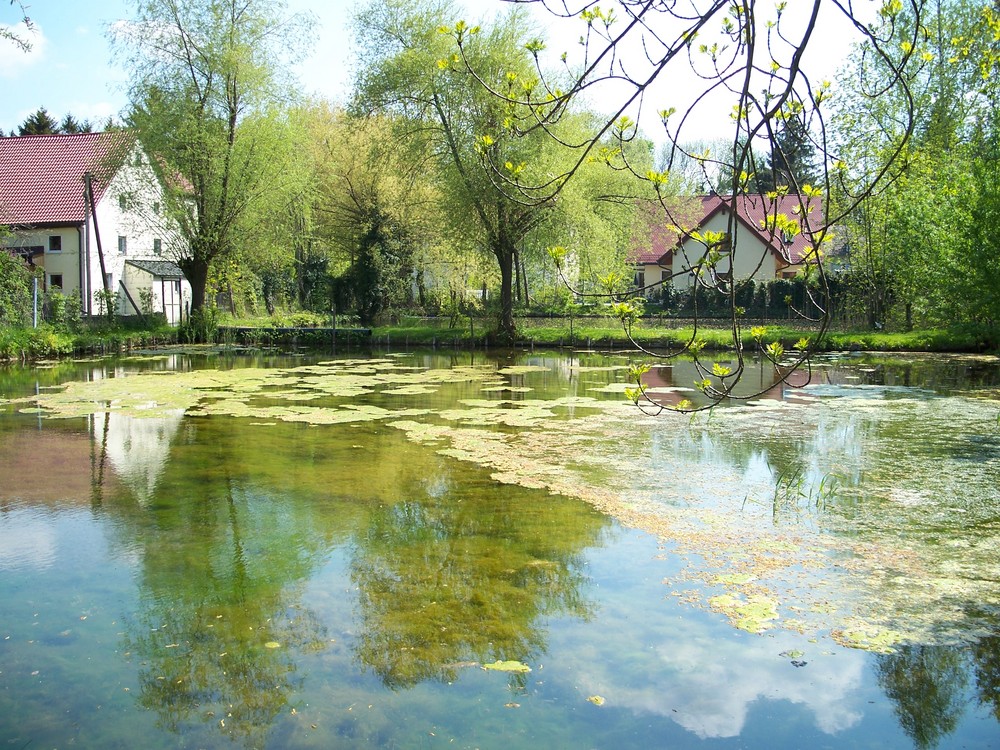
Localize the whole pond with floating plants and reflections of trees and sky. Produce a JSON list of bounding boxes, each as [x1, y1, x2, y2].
[[0, 350, 1000, 750]]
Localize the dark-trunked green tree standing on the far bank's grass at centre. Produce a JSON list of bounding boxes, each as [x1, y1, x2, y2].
[[354, 0, 636, 340]]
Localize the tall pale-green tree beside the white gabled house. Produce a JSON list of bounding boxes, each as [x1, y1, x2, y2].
[[114, 0, 308, 310]]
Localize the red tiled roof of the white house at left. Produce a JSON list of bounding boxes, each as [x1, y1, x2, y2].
[[0, 130, 134, 225]]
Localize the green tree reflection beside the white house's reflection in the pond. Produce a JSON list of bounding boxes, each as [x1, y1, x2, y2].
[[116, 423, 346, 746]]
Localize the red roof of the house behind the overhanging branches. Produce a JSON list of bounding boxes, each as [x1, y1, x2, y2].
[[630, 194, 823, 265]]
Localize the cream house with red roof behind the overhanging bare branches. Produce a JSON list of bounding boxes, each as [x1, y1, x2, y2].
[[631, 194, 823, 293]]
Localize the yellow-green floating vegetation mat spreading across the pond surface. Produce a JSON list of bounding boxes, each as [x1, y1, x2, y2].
[[9, 358, 1000, 656]]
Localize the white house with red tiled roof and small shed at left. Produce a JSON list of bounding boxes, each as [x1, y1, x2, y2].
[[0, 131, 191, 324]]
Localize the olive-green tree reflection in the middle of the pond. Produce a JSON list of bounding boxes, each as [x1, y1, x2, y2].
[[351, 488, 607, 691]]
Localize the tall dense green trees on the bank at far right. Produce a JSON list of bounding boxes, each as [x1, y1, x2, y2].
[[833, 0, 1000, 328]]
